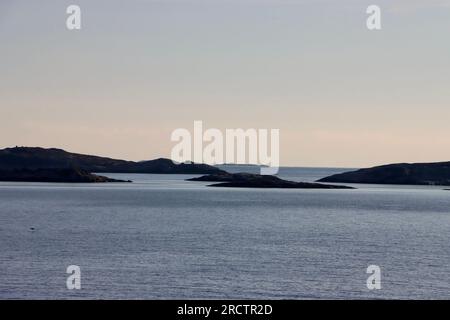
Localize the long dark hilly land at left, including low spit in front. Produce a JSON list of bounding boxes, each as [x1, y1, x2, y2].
[[0, 147, 225, 182]]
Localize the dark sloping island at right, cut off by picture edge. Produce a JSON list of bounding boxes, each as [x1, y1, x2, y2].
[[318, 162, 450, 186]]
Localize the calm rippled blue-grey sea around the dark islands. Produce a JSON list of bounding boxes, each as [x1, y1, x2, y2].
[[0, 168, 450, 299]]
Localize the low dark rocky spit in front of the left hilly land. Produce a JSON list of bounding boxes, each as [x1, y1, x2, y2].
[[0, 168, 131, 183]]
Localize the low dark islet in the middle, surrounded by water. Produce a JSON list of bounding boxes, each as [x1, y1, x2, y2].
[[187, 172, 354, 189]]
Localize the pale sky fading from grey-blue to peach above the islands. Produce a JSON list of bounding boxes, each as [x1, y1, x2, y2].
[[0, 0, 450, 168]]
